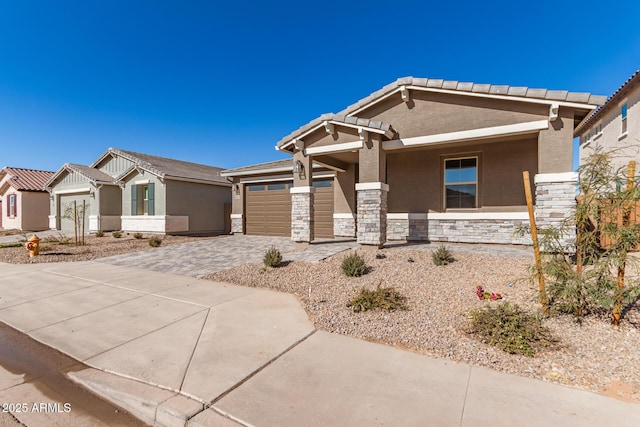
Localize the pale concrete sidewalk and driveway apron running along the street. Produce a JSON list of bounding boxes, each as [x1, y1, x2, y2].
[[0, 262, 640, 427]]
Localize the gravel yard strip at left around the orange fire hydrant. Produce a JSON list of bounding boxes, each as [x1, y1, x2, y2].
[[0, 233, 202, 264]]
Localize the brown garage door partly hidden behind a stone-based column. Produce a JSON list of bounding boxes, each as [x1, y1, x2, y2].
[[245, 180, 333, 238]]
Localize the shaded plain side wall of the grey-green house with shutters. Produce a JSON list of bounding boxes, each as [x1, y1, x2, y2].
[[165, 180, 231, 233]]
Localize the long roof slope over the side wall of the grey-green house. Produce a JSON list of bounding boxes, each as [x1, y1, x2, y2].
[[107, 148, 231, 185]]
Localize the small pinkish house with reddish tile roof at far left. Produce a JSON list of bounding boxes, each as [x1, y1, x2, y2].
[[0, 167, 53, 231]]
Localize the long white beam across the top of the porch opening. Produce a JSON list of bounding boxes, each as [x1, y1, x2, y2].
[[382, 120, 549, 150]]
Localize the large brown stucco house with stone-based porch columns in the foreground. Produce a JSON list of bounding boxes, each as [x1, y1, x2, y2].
[[223, 77, 606, 246]]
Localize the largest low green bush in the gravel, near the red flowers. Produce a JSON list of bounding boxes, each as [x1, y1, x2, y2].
[[467, 302, 558, 357]]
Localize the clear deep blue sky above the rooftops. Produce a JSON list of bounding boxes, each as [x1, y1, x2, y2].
[[0, 0, 640, 171]]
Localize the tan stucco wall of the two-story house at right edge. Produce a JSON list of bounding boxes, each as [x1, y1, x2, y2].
[[580, 84, 640, 170]]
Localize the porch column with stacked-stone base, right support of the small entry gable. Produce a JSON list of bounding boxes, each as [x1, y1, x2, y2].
[[356, 132, 389, 248]]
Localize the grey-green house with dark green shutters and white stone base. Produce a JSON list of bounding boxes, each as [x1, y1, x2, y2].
[[47, 148, 231, 234]]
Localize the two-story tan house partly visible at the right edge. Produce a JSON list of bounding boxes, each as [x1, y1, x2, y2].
[[575, 70, 640, 168]]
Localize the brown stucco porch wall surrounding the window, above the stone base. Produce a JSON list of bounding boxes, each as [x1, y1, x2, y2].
[[387, 137, 538, 213]]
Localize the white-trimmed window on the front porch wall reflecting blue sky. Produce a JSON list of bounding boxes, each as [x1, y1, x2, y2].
[[444, 157, 478, 209]]
